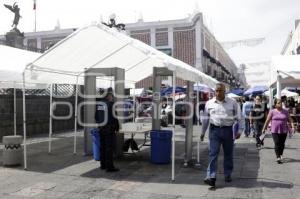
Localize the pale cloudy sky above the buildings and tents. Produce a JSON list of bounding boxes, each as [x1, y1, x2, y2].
[[0, 0, 300, 64]]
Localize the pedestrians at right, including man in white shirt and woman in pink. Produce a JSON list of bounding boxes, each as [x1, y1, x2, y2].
[[200, 83, 300, 188]]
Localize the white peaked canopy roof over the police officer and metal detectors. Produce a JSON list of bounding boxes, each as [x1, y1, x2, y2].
[[25, 24, 217, 87]]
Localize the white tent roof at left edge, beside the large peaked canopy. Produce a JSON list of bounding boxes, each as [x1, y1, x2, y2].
[[0, 45, 41, 88]]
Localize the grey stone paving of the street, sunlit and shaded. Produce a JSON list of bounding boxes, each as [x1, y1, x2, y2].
[[0, 128, 300, 199]]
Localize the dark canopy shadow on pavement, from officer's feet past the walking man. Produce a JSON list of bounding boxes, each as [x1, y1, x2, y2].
[[81, 142, 268, 188]]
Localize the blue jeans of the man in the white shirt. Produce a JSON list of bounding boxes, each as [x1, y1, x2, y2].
[[206, 127, 234, 178]]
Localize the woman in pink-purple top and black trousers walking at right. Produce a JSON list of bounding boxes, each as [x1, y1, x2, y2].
[[262, 99, 295, 164]]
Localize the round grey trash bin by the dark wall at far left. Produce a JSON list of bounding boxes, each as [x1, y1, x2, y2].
[[2, 135, 23, 166]]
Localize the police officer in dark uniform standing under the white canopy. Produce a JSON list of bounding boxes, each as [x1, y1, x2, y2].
[[96, 88, 119, 172]]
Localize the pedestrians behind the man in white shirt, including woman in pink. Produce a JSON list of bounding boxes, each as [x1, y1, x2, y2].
[[239, 95, 300, 156]]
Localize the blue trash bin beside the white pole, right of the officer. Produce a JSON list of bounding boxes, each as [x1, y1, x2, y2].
[[150, 130, 172, 164]]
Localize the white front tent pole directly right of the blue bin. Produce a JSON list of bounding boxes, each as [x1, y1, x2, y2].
[[172, 71, 176, 181]]
